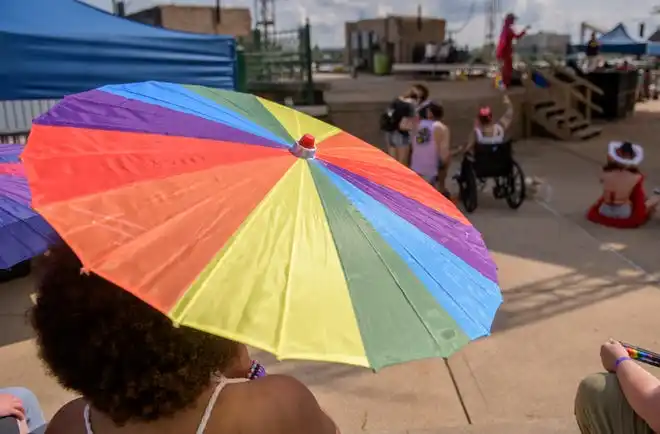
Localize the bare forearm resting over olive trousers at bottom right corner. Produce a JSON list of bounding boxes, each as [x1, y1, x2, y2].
[[616, 360, 660, 432]]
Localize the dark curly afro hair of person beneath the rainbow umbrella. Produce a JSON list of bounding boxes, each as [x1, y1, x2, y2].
[[31, 246, 237, 426]]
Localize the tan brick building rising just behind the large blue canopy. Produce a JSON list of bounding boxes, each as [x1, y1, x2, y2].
[[127, 5, 252, 38]]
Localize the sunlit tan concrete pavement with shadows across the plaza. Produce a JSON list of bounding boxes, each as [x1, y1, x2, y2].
[[0, 105, 660, 434]]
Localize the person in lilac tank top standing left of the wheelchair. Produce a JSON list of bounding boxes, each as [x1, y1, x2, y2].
[[410, 102, 450, 198]]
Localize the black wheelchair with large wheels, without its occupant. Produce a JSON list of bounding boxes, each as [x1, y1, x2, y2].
[[454, 140, 526, 213]]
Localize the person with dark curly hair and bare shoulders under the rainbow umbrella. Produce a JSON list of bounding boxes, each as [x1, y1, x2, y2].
[[31, 246, 338, 434]]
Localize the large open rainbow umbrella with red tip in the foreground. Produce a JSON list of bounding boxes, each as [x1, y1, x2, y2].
[[23, 82, 502, 369]]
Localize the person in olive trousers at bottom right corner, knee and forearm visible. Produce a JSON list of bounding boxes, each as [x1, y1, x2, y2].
[[575, 339, 660, 434]]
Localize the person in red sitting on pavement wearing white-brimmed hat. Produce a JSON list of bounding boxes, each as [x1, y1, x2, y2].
[[587, 142, 660, 228]]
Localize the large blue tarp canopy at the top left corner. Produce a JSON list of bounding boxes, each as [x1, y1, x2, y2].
[[0, 0, 236, 100]]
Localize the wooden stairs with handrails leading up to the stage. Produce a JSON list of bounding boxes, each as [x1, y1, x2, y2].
[[523, 68, 603, 141]]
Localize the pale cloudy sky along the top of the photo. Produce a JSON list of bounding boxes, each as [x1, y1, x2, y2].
[[84, 0, 660, 47]]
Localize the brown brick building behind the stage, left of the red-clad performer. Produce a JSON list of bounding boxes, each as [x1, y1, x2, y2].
[[344, 16, 447, 65]]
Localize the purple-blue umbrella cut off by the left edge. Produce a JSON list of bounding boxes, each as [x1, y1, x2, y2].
[[0, 145, 57, 269]]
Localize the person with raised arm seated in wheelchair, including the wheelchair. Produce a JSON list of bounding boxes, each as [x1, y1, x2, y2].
[[454, 94, 525, 212]]
